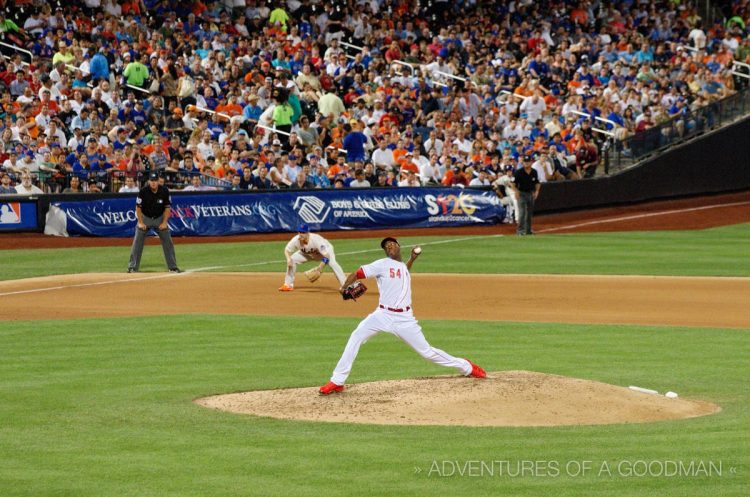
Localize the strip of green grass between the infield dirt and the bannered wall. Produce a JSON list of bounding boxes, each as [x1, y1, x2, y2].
[[0, 224, 750, 280]]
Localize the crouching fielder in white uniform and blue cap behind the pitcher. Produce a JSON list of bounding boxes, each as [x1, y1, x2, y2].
[[279, 224, 346, 292]]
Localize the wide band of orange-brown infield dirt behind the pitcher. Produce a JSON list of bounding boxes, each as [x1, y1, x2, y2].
[[0, 272, 750, 333]]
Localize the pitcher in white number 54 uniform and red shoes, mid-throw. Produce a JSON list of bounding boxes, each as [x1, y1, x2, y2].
[[320, 237, 487, 395]]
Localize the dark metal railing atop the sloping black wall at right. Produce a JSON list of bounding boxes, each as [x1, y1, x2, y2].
[[607, 84, 750, 169]]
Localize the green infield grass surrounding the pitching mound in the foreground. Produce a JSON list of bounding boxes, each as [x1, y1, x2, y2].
[[0, 315, 750, 497]]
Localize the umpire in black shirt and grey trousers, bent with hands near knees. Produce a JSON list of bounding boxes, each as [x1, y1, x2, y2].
[[128, 172, 182, 273]]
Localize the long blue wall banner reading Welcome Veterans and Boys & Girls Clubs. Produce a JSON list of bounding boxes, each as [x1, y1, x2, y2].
[[46, 188, 505, 237]]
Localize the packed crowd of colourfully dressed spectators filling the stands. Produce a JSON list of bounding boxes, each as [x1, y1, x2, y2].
[[0, 0, 750, 198]]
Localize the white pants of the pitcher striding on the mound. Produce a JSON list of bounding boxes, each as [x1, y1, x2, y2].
[[331, 309, 471, 385]]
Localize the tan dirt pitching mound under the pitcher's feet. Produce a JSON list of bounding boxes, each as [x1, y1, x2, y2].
[[196, 371, 721, 426]]
